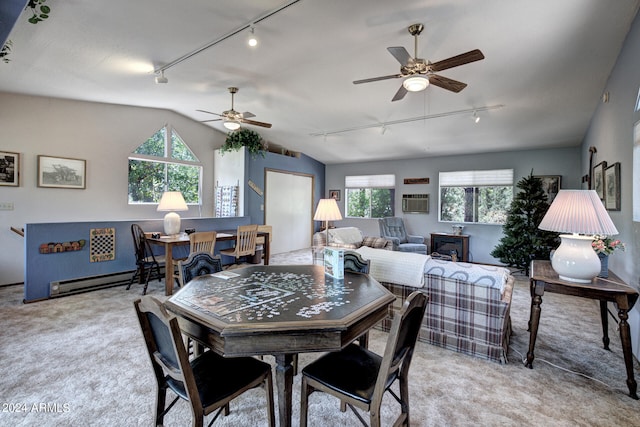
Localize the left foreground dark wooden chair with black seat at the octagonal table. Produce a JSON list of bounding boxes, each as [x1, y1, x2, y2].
[[134, 296, 275, 427]]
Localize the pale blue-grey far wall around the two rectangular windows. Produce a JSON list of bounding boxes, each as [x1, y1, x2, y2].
[[325, 146, 581, 264]]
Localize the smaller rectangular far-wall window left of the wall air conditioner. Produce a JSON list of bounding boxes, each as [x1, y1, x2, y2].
[[344, 175, 396, 218]]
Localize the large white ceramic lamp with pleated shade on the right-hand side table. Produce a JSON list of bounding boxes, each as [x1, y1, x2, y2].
[[538, 190, 618, 283]]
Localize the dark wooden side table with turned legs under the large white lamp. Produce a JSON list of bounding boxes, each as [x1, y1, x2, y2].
[[525, 261, 638, 399]]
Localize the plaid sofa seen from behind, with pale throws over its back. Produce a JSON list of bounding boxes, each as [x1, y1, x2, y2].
[[356, 247, 515, 363]]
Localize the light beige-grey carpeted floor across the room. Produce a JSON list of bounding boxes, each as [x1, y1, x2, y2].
[[0, 250, 640, 426]]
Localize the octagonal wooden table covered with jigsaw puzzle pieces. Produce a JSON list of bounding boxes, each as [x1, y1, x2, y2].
[[165, 265, 395, 426]]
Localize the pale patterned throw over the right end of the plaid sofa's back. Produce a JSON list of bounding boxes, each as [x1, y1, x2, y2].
[[424, 258, 510, 293]]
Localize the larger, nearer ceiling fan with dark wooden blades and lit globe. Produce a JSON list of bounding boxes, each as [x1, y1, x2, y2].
[[353, 24, 484, 101]]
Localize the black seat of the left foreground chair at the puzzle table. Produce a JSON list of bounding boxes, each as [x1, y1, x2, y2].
[[166, 351, 271, 406]]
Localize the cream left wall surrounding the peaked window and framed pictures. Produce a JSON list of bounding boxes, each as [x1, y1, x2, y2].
[[0, 93, 225, 285]]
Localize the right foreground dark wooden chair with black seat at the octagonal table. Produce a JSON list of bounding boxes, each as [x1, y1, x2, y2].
[[300, 291, 427, 427]]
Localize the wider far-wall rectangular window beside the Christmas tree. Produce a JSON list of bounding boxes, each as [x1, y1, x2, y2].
[[439, 169, 513, 224]]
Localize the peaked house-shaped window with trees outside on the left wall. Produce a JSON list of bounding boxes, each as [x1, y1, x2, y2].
[[129, 125, 202, 204]]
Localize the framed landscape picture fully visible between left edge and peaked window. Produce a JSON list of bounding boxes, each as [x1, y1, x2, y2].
[[38, 155, 87, 190]]
